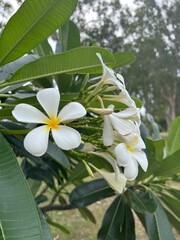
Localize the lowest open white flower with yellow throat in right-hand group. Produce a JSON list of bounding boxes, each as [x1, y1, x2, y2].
[[114, 133, 148, 180]]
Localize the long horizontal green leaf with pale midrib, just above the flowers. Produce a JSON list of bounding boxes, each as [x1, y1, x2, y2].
[[0, 47, 115, 87]]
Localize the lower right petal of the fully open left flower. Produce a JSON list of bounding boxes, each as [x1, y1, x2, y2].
[[52, 125, 81, 150]]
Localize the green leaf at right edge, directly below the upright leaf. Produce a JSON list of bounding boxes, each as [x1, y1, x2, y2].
[[155, 150, 180, 176]]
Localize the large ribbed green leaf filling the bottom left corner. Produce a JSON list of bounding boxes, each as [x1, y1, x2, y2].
[[0, 135, 52, 240]]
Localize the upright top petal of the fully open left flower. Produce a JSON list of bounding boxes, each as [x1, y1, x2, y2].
[[37, 88, 60, 117]]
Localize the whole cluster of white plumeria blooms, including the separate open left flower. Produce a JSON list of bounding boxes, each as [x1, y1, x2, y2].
[[12, 53, 148, 192]]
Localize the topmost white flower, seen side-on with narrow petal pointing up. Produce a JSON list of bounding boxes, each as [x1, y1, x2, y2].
[[96, 53, 125, 90]]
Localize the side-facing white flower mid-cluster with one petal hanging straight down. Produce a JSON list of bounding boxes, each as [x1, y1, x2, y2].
[[103, 105, 135, 146]]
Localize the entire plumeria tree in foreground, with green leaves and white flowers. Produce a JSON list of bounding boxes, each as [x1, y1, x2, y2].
[[0, 0, 180, 240]]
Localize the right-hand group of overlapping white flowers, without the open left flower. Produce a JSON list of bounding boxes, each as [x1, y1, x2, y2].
[[89, 53, 148, 186]]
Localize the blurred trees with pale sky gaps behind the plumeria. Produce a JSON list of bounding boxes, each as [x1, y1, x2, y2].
[[0, 0, 180, 130]]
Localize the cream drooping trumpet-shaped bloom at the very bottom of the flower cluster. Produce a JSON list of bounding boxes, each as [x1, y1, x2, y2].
[[90, 164, 127, 193]]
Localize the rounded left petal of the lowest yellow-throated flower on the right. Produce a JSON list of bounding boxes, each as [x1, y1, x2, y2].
[[114, 143, 132, 167]]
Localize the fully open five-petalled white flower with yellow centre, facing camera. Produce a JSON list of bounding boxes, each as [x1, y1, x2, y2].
[[12, 88, 86, 156]]
